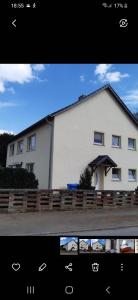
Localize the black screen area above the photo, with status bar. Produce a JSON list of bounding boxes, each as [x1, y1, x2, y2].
[[0, 0, 138, 63]]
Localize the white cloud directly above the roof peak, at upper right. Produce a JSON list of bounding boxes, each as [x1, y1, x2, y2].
[[94, 64, 129, 82]]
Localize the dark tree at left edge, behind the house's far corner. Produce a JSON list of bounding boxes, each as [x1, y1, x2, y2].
[[0, 133, 14, 167]]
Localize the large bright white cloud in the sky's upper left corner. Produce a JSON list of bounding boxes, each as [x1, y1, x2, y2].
[[0, 64, 45, 93]]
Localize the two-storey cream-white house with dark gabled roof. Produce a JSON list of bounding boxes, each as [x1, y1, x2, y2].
[[7, 85, 138, 190]]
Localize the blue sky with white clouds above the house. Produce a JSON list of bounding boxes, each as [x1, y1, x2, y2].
[[0, 64, 138, 134]]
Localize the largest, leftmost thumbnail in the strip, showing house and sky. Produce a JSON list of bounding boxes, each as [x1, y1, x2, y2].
[[60, 237, 78, 255]]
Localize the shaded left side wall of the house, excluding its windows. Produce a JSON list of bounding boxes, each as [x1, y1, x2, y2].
[[6, 124, 51, 189]]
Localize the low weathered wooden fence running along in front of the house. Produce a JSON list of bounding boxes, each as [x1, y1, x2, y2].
[[0, 189, 138, 213]]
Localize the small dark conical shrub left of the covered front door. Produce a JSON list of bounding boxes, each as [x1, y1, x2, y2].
[[79, 167, 92, 189]]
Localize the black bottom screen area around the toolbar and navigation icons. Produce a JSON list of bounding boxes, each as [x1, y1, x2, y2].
[[0, 236, 138, 299]]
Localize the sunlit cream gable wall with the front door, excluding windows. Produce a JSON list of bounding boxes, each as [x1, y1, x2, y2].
[[52, 90, 138, 190]]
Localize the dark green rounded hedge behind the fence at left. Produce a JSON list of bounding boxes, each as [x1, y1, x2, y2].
[[0, 168, 38, 189]]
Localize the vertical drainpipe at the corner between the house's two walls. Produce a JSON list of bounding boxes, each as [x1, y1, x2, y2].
[[46, 119, 54, 189]]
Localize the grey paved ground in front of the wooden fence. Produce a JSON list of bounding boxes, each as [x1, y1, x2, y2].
[[0, 207, 138, 236]]
